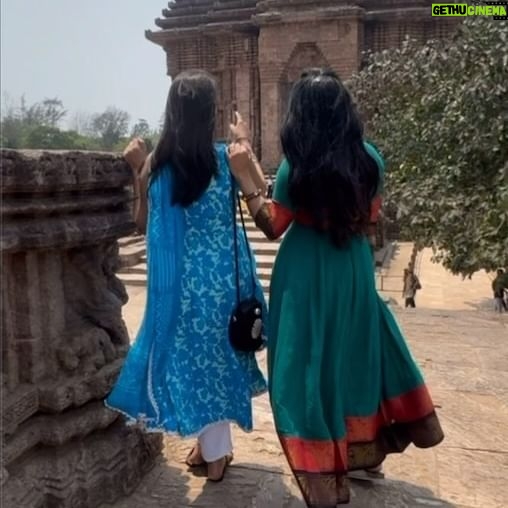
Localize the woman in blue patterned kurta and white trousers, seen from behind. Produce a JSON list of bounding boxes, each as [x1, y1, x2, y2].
[[107, 71, 266, 481]]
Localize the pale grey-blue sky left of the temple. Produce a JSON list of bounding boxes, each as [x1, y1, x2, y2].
[[0, 0, 173, 131]]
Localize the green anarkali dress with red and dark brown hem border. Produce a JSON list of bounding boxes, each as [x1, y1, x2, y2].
[[268, 144, 443, 508]]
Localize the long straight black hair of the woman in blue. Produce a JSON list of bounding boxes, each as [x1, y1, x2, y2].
[[152, 70, 218, 207]]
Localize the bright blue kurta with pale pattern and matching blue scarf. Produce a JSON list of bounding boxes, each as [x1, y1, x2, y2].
[[107, 145, 267, 436]]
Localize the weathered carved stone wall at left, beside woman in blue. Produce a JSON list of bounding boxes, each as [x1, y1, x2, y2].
[[0, 150, 161, 508]]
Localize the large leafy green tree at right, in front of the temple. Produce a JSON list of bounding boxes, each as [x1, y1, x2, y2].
[[349, 17, 508, 276]]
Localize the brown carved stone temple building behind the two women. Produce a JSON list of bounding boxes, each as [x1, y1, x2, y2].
[[146, 0, 457, 169]]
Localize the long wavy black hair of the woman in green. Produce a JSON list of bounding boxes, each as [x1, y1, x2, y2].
[[281, 69, 379, 247]]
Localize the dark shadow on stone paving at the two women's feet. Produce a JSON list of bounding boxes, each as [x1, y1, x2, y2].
[[102, 459, 455, 508]]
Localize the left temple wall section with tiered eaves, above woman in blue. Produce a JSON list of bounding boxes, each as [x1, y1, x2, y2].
[[147, 0, 261, 152]]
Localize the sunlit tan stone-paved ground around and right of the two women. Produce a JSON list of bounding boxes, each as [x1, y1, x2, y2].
[[103, 280, 508, 508]]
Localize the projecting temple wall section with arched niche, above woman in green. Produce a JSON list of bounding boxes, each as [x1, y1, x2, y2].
[[257, 1, 363, 168]]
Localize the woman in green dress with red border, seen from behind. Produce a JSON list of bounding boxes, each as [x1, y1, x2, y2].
[[230, 70, 443, 508]]
